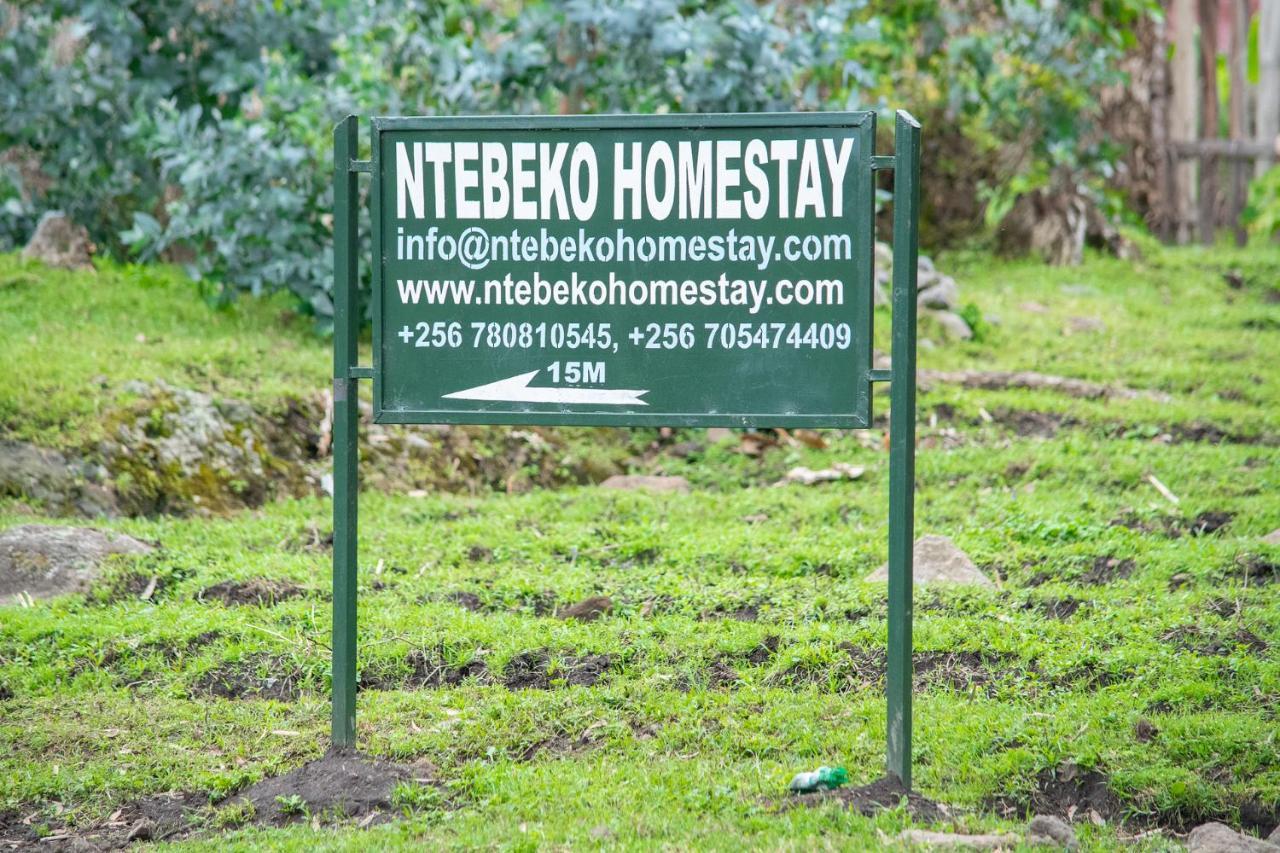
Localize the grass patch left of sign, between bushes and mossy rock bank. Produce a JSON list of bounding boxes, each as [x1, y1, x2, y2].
[[0, 255, 333, 446]]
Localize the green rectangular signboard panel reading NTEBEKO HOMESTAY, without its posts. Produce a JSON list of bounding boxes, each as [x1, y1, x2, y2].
[[372, 113, 874, 427]]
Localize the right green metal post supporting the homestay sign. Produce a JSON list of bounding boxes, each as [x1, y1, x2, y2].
[[886, 110, 920, 788]]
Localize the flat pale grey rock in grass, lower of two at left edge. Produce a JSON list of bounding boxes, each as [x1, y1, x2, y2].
[[0, 524, 154, 602]]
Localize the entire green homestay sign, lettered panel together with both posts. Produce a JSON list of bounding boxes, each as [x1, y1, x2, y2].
[[333, 110, 920, 786]]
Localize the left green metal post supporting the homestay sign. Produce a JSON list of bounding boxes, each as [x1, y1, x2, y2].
[[333, 115, 360, 747]]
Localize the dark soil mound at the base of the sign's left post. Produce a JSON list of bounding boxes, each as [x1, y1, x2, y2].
[[223, 749, 413, 826]]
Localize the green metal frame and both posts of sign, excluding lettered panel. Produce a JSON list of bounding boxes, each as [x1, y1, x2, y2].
[[332, 110, 920, 788]]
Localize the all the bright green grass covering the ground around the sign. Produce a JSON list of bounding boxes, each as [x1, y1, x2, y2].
[[0, 242, 1280, 849]]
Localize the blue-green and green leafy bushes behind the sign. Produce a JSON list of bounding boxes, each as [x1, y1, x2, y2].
[[0, 0, 1274, 324]]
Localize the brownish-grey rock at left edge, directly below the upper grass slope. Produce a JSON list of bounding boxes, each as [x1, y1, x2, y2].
[[0, 442, 118, 517]]
